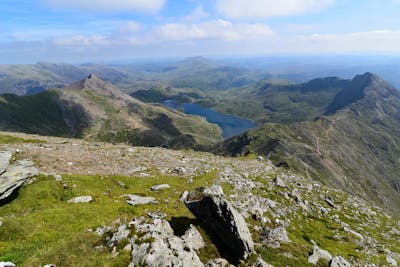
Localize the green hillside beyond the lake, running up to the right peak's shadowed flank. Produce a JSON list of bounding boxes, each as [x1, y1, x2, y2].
[[214, 73, 390, 123]]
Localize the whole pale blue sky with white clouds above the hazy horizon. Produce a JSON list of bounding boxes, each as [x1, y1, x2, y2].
[[0, 0, 400, 63]]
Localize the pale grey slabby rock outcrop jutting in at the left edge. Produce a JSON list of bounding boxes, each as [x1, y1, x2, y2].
[[0, 152, 38, 200]]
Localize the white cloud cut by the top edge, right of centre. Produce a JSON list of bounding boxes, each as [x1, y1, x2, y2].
[[216, 0, 335, 19]]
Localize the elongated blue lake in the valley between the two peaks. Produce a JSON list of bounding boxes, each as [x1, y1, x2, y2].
[[161, 100, 256, 139]]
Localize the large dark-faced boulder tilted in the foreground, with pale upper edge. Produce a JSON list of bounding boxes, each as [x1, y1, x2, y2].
[[184, 187, 254, 260]]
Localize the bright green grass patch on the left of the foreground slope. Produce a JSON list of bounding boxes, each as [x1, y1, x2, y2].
[[0, 173, 220, 266]]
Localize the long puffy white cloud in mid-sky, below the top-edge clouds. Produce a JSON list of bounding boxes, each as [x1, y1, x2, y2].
[[154, 19, 273, 41]]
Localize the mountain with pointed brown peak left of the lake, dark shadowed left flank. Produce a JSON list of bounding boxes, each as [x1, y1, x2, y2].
[[0, 75, 221, 147]]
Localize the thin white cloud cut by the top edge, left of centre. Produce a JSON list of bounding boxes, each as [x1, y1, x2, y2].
[[43, 0, 165, 13]]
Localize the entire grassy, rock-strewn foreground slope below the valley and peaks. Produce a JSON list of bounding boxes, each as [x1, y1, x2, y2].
[[0, 133, 400, 266]]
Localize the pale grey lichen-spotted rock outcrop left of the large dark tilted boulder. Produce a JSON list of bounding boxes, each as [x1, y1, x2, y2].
[[96, 217, 205, 267]]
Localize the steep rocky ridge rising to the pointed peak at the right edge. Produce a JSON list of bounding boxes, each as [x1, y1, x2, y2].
[[217, 73, 400, 216]]
